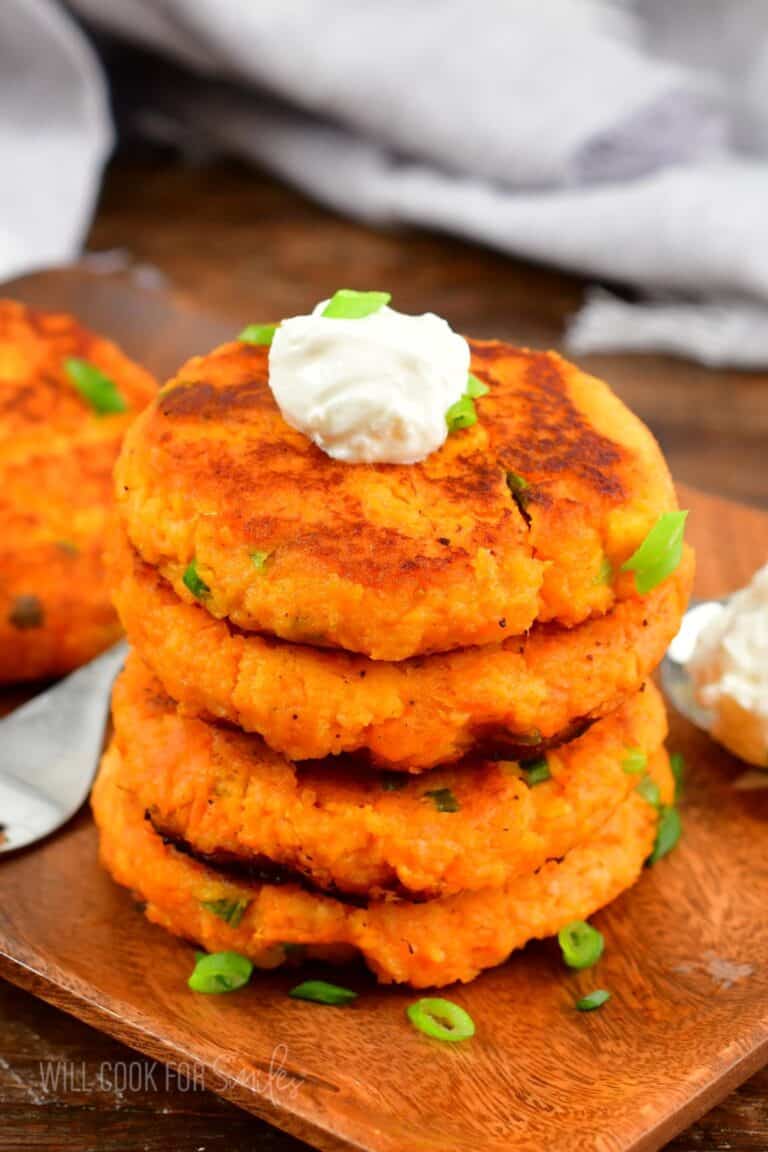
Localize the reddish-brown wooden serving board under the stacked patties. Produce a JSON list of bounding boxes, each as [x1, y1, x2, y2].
[[0, 264, 768, 1152]]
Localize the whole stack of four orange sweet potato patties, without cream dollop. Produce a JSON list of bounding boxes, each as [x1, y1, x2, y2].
[[93, 329, 693, 986]]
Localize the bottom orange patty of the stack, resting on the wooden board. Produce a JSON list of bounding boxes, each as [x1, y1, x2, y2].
[[92, 748, 672, 987]]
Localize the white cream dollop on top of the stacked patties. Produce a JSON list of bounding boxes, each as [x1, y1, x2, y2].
[[269, 301, 470, 464]]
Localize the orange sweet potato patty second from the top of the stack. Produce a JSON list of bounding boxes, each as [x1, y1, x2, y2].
[[112, 533, 693, 772]]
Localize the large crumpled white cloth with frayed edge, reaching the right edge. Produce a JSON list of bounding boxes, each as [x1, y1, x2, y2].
[[7, 0, 768, 364]]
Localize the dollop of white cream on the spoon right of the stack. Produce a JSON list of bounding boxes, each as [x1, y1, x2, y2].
[[689, 564, 768, 768]]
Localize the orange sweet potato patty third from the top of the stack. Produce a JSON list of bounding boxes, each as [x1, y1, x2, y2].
[[113, 654, 667, 897]]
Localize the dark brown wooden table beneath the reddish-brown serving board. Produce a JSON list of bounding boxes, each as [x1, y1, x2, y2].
[[0, 157, 768, 1152]]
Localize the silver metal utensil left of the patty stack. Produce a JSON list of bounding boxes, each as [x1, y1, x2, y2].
[[0, 642, 128, 852]]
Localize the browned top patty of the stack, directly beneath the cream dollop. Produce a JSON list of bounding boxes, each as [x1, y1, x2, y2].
[[117, 342, 676, 660]]
